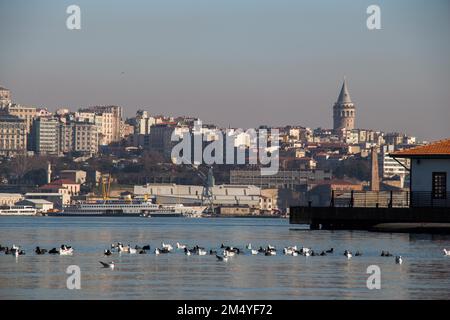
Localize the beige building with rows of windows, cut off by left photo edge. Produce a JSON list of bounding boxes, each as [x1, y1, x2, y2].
[[0, 113, 27, 156]]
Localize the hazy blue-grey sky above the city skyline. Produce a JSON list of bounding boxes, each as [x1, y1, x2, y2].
[[0, 0, 450, 140]]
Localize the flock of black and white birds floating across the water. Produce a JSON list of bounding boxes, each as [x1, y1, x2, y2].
[[0, 242, 450, 269]]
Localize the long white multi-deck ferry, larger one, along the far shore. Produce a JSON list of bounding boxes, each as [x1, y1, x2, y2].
[[48, 199, 183, 217]]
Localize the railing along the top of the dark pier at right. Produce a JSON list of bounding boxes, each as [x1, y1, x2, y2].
[[330, 190, 450, 208]]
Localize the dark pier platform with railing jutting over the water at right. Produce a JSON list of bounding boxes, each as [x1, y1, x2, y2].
[[289, 191, 450, 233]]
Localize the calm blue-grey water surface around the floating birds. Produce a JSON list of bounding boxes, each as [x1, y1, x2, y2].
[[0, 217, 450, 299]]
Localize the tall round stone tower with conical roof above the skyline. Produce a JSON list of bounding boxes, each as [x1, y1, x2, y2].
[[333, 77, 355, 131]]
